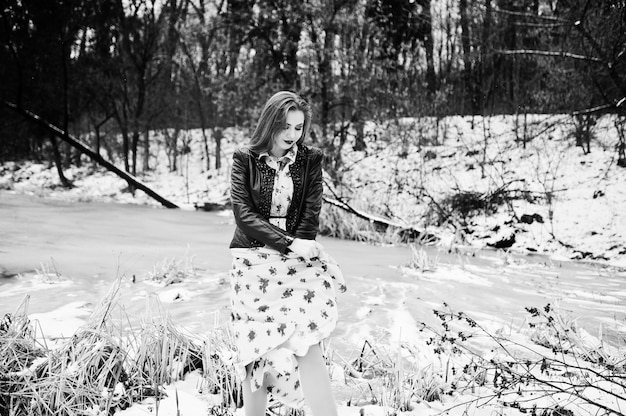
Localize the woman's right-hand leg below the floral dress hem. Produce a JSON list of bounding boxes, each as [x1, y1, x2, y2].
[[296, 345, 337, 416]]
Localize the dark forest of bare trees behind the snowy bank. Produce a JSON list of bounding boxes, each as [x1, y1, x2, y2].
[[0, 0, 626, 172]]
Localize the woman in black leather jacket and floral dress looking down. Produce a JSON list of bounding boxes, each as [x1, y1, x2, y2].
[[230, 91, 345, 416]]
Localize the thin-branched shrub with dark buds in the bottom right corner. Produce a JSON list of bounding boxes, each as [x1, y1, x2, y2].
[[416, 305, 626, 416]]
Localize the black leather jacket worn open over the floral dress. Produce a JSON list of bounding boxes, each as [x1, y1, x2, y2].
[[230, 145, 323, 253]]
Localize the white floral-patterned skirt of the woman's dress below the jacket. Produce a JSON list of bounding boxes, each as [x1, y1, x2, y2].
[[230, 247, 346, 408]]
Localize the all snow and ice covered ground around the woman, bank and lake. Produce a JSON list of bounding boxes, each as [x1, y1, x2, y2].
[[0, 114, 626, 416]]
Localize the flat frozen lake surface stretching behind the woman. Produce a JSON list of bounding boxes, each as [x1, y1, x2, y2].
[[0, 192, 626, 352]]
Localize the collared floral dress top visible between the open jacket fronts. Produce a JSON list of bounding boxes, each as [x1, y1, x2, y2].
[[259, 145, 298, 230]]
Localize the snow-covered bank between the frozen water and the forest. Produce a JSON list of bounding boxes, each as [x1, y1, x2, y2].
[[0, 116, 626, 266]]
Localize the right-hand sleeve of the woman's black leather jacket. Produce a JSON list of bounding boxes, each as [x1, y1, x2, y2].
[[295, 149, 324, 240]]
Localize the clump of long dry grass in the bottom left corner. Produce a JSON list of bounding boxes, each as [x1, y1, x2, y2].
[[0, 279, 201, 416]]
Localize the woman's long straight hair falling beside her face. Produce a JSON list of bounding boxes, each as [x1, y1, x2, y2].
[[248, 91, 312, 153]]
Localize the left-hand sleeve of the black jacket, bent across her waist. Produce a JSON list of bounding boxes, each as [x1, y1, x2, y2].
[[230, 150, 291, 253]]
